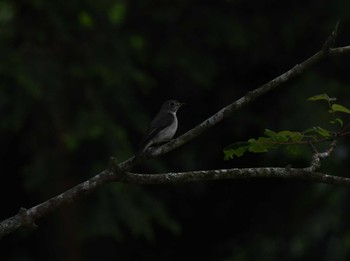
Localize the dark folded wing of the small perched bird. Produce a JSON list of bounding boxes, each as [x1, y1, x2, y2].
[[139, 112, 174, 150]]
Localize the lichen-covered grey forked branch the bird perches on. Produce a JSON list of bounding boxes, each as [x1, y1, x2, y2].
[[0, 23, 350, 238]]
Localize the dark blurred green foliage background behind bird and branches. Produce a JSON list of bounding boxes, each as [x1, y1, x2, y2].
[[0, 0, 350, 261]]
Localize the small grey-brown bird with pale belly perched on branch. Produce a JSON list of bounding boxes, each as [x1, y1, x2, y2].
[[138, 100, 184, 154]]
